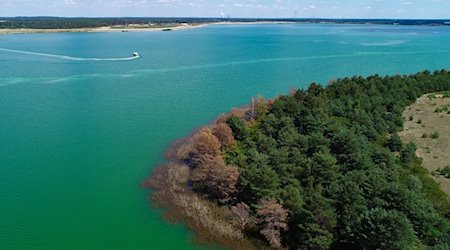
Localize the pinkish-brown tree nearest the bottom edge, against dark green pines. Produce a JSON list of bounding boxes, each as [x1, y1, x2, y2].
[[256, 199, 288, 248]]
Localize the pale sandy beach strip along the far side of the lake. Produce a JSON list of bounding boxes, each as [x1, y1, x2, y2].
[[0, 22, 292, 35]]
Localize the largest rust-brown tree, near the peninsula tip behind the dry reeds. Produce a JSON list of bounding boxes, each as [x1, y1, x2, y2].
[[191, 156, 239, 204]]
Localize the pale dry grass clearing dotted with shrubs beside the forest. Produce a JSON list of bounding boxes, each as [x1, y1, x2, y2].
[[400, 94, 450, 194]]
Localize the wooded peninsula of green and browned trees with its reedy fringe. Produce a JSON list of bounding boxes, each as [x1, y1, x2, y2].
[[145, 70, 450, 249]]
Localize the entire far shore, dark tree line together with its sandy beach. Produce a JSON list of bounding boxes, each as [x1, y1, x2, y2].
[[0, 16, 450, 35]]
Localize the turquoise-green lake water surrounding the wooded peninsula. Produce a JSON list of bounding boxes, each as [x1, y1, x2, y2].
[[0, 25, 450, 249]]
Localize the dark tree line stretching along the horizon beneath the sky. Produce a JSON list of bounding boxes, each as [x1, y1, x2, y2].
[[0, 17, 450, 29]]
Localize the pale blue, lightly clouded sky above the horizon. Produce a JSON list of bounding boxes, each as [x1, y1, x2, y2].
[[0, 0, 450, 19]]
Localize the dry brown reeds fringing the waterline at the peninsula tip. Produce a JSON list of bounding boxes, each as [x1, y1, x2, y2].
[[143, 163, 258, 250]]
